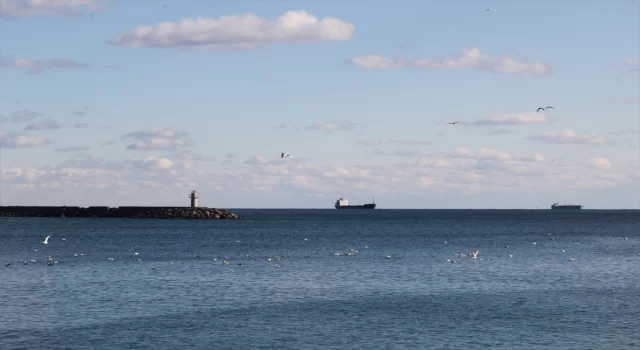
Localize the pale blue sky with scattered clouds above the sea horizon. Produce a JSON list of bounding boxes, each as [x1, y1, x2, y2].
[[0, 0, 640, 209]]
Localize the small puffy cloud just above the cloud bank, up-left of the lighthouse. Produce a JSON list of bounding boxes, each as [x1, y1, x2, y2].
[[123, 128, 192, 150]]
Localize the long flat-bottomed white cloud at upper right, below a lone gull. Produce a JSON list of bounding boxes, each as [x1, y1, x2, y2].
[[351, 47, 550, 75]]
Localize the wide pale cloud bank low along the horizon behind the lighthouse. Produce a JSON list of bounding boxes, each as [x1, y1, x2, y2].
[[0, 148, 636, 207]]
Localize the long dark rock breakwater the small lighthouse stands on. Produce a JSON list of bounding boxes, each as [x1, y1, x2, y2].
[[0, 206, 242, 219]]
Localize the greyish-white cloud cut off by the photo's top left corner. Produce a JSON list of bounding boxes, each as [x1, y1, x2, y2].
[[0, 0, 98, 17]]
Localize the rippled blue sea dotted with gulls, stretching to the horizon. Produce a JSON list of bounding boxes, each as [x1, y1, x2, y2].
[[0, 209, 640, 350]]
